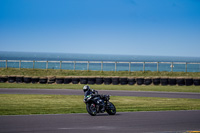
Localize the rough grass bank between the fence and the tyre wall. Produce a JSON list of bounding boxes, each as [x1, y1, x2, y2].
[[0, 68, 200, 77]]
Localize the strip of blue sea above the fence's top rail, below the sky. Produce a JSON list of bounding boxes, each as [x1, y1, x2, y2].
[[0, 51, 200, 63]]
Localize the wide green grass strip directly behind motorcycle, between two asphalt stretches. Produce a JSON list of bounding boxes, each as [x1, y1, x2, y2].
[[0, 94, 200, 115]]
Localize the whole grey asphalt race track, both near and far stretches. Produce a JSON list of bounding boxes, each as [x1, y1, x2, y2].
[[0, 88, 200, 133]]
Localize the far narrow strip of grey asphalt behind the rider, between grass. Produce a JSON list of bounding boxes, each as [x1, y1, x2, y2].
[[0, 88, 200, 99]]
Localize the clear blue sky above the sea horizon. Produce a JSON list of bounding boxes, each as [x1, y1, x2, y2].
[[0, 0, 200, 57]]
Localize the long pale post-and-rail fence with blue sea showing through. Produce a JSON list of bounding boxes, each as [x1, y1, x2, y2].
[[0, 60, 200, 72]]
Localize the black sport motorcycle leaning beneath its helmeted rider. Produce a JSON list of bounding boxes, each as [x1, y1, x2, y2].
[[84, 91, 116, 116]]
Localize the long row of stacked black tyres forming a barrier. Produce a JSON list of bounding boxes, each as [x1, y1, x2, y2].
[[0, 75, 200, 86]]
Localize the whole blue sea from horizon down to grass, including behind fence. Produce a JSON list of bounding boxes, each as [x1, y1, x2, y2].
[[0, 51, 200, 72]]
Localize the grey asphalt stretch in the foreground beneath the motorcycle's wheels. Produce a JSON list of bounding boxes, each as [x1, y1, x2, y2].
[[0, 111, 200, 133]]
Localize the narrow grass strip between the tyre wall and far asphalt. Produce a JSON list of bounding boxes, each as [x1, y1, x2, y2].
[[0, 83, 200, 93]]
